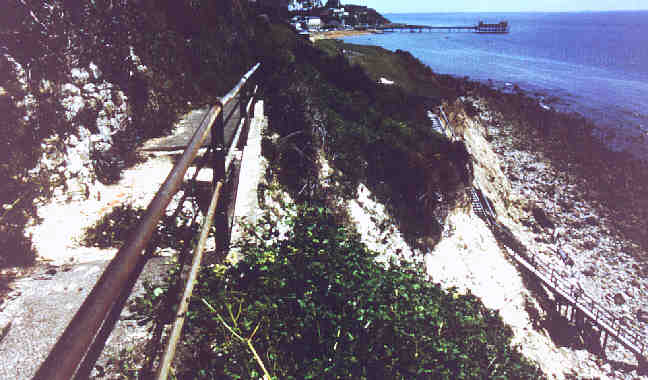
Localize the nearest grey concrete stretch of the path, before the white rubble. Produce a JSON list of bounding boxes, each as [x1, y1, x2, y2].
[[0, 257, 167, 380]]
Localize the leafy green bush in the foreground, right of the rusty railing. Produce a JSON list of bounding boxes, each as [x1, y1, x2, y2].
[[170, 204, 543, 379]]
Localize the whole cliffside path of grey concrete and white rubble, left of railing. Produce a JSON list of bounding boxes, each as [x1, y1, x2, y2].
[[0, 99, 239, 380]]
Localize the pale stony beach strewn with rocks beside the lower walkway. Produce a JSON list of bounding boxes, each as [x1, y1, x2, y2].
[[448, 96, 648, 379]]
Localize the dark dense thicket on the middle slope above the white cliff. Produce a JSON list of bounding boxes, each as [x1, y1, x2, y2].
[[265, 37, 469, 245]]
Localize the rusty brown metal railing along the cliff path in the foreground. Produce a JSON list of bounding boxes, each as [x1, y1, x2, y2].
[[33, 63, 260, 380]]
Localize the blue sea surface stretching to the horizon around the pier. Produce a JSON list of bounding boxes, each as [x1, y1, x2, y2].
[[344, 11, 648, 159]]
